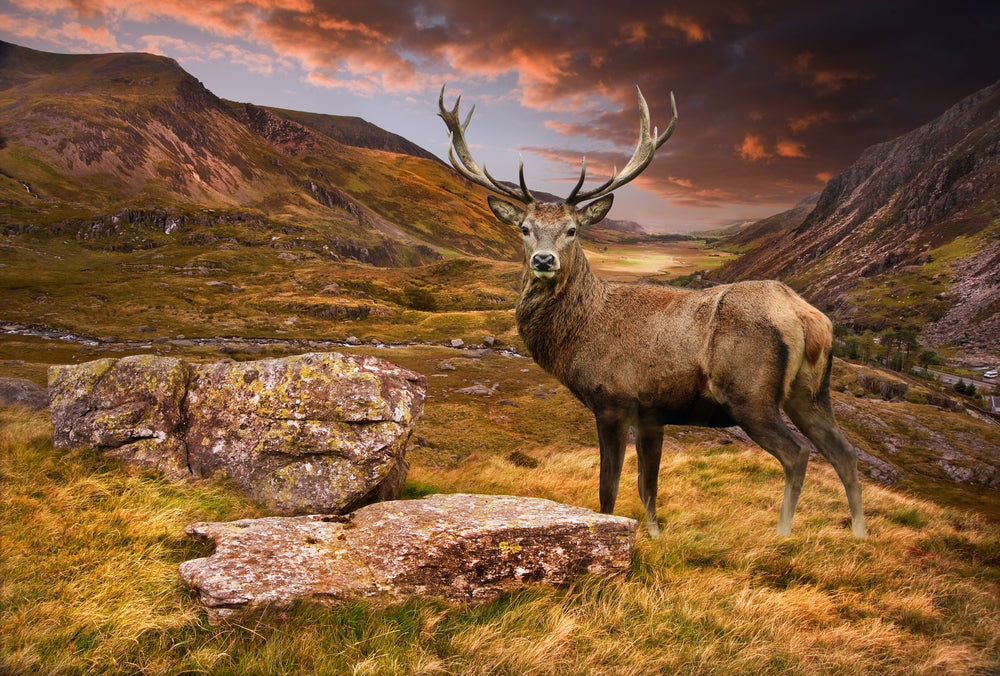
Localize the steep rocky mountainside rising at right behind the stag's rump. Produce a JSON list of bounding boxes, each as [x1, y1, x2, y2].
[[714, 82, 1000, 353]]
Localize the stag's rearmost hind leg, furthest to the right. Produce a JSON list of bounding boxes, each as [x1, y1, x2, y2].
[[785, 391, 868, 538]]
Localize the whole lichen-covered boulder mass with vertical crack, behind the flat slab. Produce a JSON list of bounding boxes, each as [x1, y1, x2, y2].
[[49, 353, 426, 514]]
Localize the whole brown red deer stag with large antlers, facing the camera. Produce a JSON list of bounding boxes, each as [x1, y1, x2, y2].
[[438, 87, 867, 537]]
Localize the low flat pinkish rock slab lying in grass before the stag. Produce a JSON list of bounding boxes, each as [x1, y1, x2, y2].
[[179, 494, 636, 624]]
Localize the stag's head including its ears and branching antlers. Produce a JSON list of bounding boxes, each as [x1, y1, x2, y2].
[[438, 86, 677, 279]]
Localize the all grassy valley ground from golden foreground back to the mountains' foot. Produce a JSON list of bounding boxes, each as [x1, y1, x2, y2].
[[0, 231, 1000, 674]]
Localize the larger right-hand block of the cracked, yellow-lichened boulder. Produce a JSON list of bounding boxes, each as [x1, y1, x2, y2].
[[184, 354, 426, 513]]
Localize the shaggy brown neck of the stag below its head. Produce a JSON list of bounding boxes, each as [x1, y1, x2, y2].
[[515, 244, 606, 378]]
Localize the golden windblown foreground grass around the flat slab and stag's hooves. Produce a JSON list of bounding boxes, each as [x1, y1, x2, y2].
[[0, 390, 1000, 675]]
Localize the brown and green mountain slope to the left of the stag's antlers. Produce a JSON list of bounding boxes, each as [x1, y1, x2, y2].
[[0, 43, 520, 265]]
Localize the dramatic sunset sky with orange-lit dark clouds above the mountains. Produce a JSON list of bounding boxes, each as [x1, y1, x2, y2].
[[0, 0, 1000, 232]]
